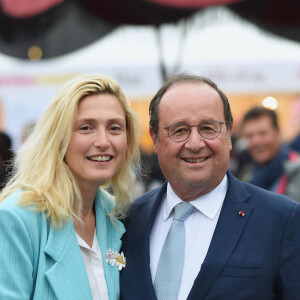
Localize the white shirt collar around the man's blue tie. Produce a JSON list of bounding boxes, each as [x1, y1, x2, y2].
[[163, 174, 228, 221]]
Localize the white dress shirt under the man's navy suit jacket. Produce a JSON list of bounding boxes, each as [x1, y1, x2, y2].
[[150, 175, 228, 300]]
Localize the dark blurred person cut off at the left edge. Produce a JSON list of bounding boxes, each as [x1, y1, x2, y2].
[[0, 132, 13, 191]]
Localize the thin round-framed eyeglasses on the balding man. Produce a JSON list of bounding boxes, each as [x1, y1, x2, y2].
[[161, 120, 226, 143]]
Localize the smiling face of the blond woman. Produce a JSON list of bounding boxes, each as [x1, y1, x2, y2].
[[65, 94, 127, 189]]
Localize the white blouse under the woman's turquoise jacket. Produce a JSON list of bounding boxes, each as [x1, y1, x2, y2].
[[75, 230, 109, 300]]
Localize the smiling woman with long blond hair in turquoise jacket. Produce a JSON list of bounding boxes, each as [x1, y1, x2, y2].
[[0, 75, 138, 300]]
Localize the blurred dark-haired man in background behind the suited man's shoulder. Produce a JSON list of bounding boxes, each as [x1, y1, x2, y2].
[[238, 107, 300, 202]]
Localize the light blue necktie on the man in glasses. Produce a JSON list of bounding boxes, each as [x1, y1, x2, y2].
[[154, 202, 194, 300]]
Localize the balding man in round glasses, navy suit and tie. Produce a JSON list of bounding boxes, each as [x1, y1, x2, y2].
[[121, 74, 300, 300]]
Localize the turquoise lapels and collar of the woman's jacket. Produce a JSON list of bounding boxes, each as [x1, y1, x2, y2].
[[44, 190, 125, 299]]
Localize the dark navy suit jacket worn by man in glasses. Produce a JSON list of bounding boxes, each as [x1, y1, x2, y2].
[[121, 172, 300, 300]]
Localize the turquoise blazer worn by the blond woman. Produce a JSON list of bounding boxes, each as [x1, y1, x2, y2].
[[0, 190, 125, 300]]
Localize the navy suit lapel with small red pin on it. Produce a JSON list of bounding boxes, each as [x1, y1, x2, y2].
[[188, 173, 253, 299]]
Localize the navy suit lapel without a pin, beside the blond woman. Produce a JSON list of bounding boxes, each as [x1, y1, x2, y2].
[[132, 183, 167, 300]]
